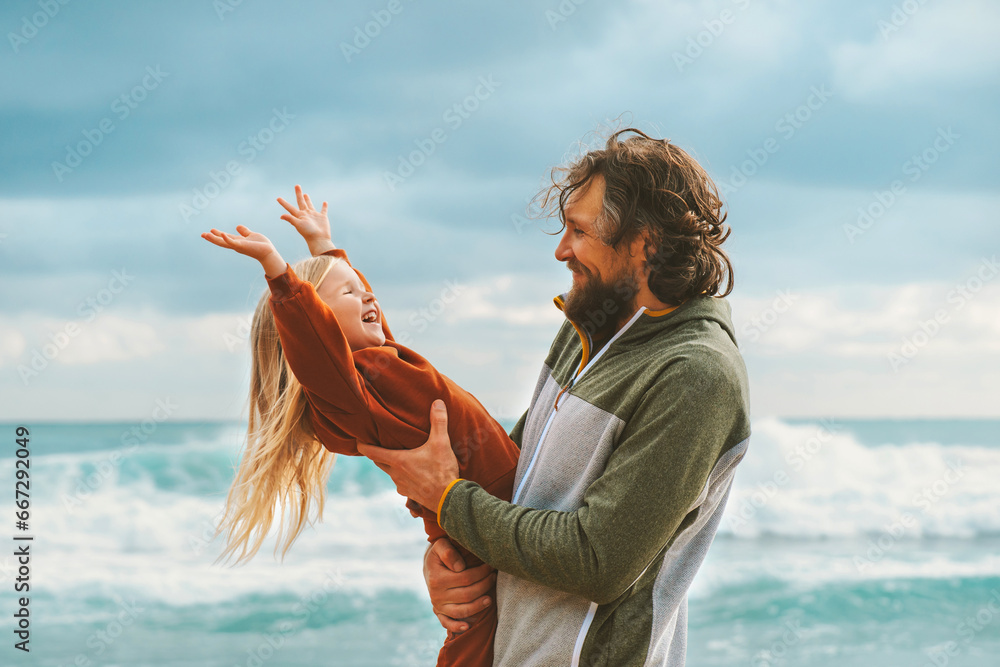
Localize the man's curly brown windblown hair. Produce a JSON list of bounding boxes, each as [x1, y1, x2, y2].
[[534, 127, 734, 305]]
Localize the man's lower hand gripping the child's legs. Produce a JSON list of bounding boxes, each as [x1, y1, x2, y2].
[[424, 538, 496, 634]]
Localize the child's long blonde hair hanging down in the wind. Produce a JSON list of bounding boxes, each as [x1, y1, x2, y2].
[[215, 255, 339, 565]]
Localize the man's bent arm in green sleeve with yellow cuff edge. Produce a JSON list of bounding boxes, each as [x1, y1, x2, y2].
[[439, 362, 748, 604]]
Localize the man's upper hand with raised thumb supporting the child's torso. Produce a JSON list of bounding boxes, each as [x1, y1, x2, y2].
[[358, 399, 458, 511]]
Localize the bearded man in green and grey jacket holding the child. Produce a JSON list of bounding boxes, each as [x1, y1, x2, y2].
[[359, 129, 750, 667]]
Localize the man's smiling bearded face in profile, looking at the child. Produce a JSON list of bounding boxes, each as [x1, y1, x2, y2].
[[556, 174, 641, 341]]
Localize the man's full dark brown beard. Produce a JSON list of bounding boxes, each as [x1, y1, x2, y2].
[[563, 260, 639, 342]]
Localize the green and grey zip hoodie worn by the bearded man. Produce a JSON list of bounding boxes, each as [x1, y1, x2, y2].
[[439, 295, 750, 667]]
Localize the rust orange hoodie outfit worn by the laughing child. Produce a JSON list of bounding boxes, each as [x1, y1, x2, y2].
[[267, 248, 520, 667]]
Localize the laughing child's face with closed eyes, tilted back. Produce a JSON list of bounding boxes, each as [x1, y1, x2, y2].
[[316, 261, 385, 352]]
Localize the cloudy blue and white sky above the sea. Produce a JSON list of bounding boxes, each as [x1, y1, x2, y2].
[[0, 0, 1000, 421]]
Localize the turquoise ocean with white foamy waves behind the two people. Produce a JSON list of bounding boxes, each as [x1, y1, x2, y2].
[[0, 418, 1000, 667]]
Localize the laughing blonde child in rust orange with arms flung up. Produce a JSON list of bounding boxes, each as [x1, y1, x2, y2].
[[202, 186, 520, 667]]
